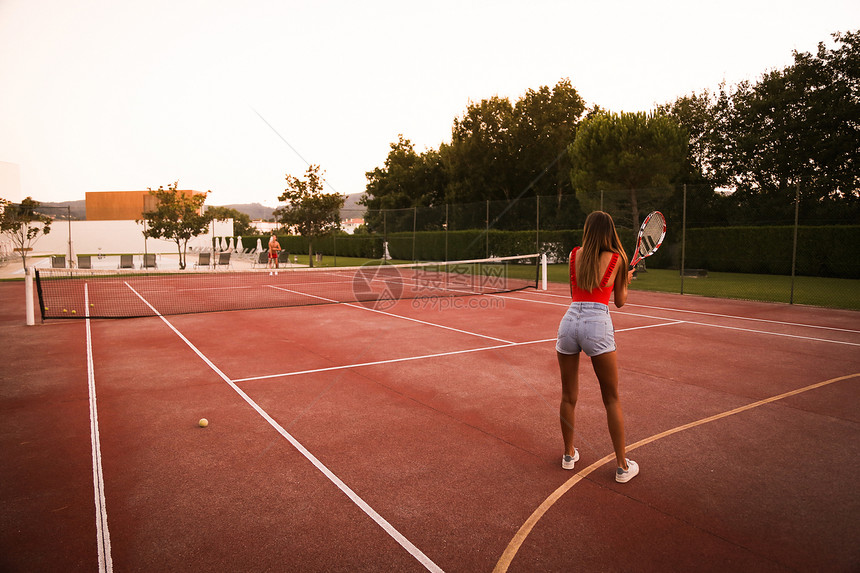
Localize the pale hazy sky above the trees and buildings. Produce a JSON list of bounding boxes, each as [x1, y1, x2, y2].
[[0, 0, 860, 206]]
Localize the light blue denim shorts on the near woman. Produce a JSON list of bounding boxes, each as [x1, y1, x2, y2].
[[555, 302, 615, 356]]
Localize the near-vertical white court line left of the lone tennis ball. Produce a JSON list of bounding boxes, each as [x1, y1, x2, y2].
[[84, 283, 113, 573]]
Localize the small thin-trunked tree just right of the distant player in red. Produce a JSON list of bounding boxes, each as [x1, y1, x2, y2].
[[275, 165, 345, 267]]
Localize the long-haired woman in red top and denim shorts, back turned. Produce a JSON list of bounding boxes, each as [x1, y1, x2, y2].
[[555, 211, 639, 483]]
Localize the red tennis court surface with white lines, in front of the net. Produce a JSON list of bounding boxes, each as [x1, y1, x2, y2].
[[0, 276, 860, 572]]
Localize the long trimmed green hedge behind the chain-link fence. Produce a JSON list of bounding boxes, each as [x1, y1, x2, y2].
[[242, 225, 860, 278]]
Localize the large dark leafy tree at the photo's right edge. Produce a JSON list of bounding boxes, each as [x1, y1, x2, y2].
[[663, 32, 860, 222]]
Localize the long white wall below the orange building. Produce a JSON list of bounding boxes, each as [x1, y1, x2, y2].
[[32, 219, 233, 255]]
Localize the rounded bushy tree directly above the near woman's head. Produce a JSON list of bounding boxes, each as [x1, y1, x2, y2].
[[569, 112, 688, 229]]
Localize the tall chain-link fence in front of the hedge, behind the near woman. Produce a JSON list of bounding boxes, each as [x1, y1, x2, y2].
[[336, 186, 860, 310]]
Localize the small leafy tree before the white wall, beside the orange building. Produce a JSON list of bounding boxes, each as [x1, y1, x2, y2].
[[137, 181, 211, 269]]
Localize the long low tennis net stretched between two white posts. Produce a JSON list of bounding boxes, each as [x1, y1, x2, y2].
[[35, 255, 541, 320]]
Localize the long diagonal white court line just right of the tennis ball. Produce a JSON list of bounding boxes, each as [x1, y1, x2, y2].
[[125, 283, 442, 573]]
